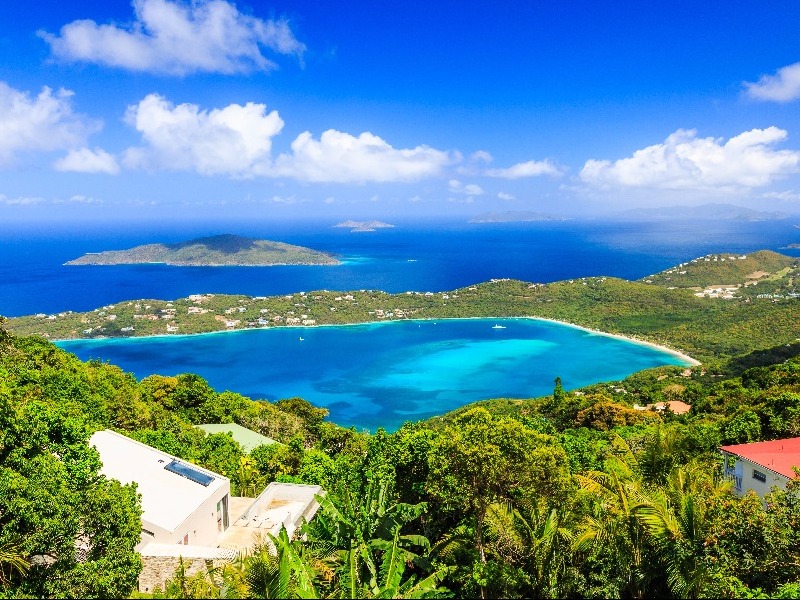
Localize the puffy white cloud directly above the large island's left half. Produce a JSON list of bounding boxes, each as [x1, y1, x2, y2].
[[123, 94, 283, 177]]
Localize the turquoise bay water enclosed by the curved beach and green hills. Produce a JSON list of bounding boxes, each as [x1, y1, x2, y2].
[[58, 319, 686, 431]]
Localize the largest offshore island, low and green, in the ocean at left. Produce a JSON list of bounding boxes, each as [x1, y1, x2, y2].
[[65, 234, 340, 267]]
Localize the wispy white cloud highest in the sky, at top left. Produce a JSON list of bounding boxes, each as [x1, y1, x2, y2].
[[39, 0, 305, 75]]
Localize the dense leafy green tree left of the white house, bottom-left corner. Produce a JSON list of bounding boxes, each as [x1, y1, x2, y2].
[[0, 394, 141, 598]]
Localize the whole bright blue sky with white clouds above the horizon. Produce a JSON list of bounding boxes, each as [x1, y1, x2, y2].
[[0, 0, 800, 221]]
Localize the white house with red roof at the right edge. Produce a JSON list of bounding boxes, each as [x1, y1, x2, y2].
[[720, 437, 800, 498]]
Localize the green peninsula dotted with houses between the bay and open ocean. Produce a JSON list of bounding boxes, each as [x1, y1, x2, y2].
[[6, 251, 800, 362]]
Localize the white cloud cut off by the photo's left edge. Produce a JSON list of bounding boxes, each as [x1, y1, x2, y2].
[[0, 82, 100, 166]]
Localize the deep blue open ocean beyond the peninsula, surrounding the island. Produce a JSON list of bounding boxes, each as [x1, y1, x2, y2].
[[0, 220, 800, 317]]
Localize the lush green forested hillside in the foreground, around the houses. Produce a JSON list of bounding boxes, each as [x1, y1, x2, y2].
[[0, 316, 800, 598]]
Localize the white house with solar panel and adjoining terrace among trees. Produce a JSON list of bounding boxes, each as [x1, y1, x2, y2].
[[89, 429, 324, 592]]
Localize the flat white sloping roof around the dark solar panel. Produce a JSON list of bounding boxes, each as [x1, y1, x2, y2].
[[89, 429, 229, 533]]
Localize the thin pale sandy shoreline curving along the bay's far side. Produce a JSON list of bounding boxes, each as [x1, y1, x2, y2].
[[50, 316, 702, 367]]
